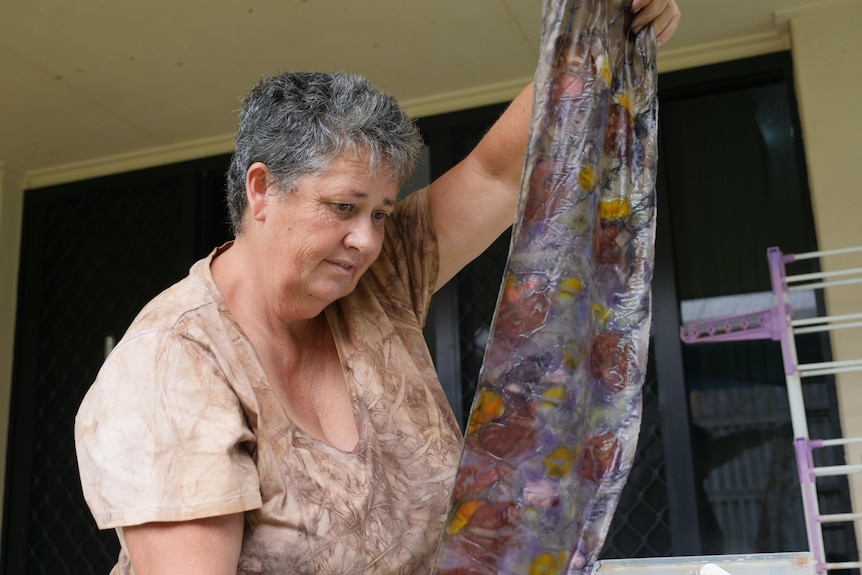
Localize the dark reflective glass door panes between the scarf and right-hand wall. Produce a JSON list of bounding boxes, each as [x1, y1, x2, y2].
[[661, 53, 857, 561]]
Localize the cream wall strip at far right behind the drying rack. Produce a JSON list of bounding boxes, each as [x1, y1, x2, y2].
[[790, 1, 862, 541]]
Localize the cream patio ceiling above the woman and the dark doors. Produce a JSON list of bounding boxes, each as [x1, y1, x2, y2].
[[0, 0, 862, 182]]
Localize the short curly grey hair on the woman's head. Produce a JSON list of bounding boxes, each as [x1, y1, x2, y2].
[[226, 72, 422, 234]]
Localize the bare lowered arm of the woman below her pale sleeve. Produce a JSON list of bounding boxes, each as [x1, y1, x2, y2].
[[123, 513, 243, 575]]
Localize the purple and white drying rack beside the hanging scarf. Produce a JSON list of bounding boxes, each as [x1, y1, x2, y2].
[[680, 246, 862, 573]]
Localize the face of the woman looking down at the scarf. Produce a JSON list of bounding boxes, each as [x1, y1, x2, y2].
[[260, 156, 398, 315]]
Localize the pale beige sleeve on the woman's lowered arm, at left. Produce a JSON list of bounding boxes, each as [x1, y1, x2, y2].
[[75, 331, 261, 529]]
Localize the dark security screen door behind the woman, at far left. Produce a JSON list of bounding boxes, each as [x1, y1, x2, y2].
[[2, 157, 233, 575]]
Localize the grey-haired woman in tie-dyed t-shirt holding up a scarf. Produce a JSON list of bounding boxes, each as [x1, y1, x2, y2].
[[75, 0, 679, 575]]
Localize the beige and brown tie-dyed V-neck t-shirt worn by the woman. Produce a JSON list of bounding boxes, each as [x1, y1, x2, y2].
[[75, 192, 461, 574]]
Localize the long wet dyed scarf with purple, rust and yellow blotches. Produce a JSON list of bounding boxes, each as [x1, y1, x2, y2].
[[435, 0, 657, 575]]
